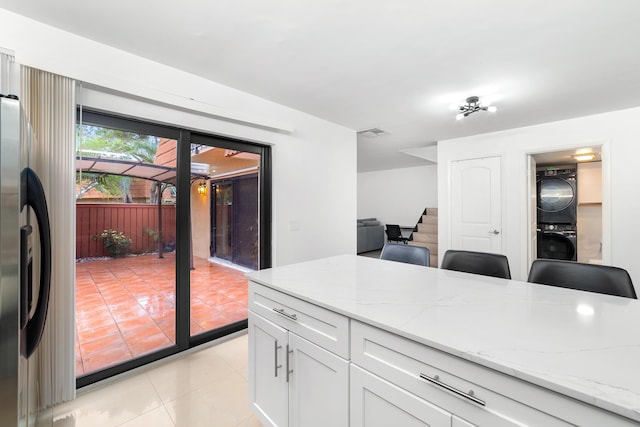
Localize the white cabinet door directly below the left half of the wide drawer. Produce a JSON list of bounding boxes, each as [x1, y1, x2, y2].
[[350, 365, 451, 427]]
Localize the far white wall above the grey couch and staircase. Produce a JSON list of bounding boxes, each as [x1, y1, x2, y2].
[[358, 165, 438, 226]]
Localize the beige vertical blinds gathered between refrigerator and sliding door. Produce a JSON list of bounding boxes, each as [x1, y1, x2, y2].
[[21, 66, 75, 408]]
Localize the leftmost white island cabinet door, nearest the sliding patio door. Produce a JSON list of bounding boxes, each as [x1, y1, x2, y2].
[[249, 312, 289, 427]]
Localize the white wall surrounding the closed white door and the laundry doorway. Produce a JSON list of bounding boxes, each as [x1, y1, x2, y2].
[[438, 108, 640, 291]]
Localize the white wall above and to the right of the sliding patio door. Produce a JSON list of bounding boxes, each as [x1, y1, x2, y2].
[[0, 9, 356, 266]]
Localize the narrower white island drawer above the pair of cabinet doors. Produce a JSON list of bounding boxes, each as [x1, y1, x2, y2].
[[249, 282, 349, 359]]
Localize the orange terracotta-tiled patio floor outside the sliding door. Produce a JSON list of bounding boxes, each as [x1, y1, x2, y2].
[[75, 252, 247, 376]]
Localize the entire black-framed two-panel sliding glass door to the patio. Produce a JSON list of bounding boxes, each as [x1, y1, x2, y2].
[[75, 111, 270, 387]]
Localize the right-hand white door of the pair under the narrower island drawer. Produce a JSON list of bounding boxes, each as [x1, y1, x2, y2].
[[289, 333, 349, 427]]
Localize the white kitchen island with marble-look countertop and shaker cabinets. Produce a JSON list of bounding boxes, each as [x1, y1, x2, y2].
[[248, 255, 640, 427]]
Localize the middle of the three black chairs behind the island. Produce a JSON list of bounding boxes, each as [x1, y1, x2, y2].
[[440, 249, 511, 279]]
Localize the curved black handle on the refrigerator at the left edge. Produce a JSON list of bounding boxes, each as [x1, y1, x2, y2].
[[20, 168, 51, 358]]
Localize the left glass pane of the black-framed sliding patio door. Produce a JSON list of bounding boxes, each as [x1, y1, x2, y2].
[[75, 114, 177, 377]]
